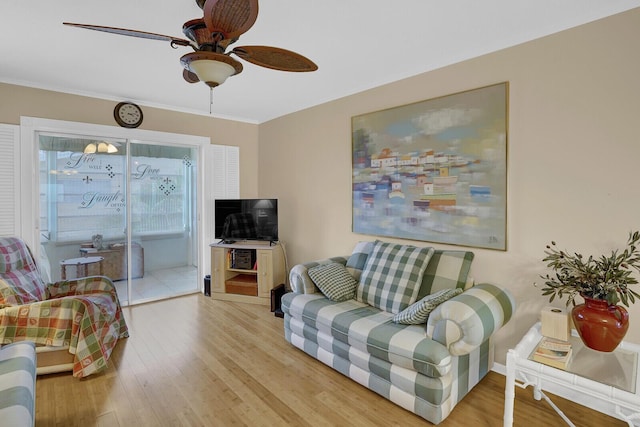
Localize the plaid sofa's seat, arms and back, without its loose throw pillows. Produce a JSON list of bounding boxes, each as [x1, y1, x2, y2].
[[282, 242, 515, 424]]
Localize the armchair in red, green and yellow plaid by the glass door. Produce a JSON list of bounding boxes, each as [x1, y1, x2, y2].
[[0, 237, 129, 378]]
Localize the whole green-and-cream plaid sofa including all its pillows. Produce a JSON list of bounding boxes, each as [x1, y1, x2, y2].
[[282, 241, 515, 424]]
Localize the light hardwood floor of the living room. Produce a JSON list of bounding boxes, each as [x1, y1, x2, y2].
[[33, 294, 626, 427]]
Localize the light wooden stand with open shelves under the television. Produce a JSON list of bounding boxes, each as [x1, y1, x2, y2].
[[210, 243, 286, 305]]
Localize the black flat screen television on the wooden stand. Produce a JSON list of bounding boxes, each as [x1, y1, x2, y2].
[[215, 199, 278, 243]]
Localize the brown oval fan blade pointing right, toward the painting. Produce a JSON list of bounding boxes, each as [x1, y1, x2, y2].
[[233, 46, 318, 72]]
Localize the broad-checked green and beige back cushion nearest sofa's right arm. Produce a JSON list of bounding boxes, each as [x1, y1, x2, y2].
[[418, 250, 474, 299]]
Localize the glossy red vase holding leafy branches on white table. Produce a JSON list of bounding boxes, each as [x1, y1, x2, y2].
[[571, 295, 629, 352]]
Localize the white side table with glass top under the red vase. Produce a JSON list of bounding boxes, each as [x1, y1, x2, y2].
[[504, 323, 640, 427]]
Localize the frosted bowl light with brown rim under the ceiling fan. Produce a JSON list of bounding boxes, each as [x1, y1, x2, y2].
[[180, 51, 242, 87]]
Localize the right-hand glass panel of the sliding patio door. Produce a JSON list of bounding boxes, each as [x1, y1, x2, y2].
[[129, 142, 199, 300]]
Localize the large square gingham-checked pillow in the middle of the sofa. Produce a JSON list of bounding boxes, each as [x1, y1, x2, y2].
[[356, 242, 433, 314]]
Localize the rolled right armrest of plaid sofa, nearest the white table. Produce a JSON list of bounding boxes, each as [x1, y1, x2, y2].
[[426, 283, 516, 356]]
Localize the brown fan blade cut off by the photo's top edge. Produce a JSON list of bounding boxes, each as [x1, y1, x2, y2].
[[203, 0, 258, 40]]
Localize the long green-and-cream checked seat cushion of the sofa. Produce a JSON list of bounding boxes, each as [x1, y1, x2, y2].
[[282, 293, 451, 378]]
